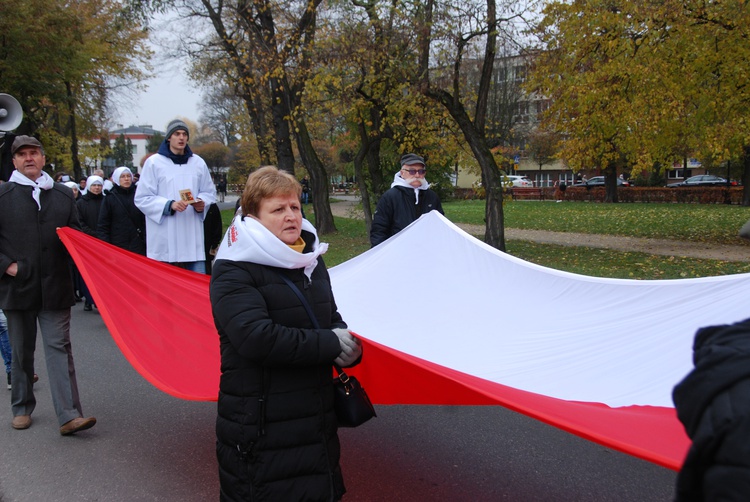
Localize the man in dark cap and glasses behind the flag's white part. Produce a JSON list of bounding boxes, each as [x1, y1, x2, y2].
[[370, 153, 445, 247]]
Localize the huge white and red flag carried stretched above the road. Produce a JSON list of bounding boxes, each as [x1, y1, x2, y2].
[[59, 211, 750, 470]]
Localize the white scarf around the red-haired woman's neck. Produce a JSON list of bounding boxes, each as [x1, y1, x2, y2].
[[216, 213, 328, 279]]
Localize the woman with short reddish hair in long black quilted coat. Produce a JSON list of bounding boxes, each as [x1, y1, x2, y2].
[[210, 166, 362, 501]]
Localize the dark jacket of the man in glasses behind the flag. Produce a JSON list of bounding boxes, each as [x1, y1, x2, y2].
[[370, 186, 445, 247]]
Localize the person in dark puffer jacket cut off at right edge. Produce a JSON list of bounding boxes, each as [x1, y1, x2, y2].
[[672, 319, 750, 502]]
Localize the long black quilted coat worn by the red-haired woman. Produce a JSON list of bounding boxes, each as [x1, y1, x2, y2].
[[211, 234, 346, 501]]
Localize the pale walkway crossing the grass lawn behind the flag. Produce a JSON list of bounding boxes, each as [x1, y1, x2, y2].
[[331, 195, 750, 262]]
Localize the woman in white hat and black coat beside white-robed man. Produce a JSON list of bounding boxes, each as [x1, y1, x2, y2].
[[97, 166, 146, 256]]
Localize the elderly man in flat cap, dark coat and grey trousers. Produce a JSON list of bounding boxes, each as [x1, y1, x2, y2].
[[0, 136, 96, 435]]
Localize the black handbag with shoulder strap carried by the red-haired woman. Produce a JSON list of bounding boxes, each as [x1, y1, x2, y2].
[[279, 273, 377, 427]]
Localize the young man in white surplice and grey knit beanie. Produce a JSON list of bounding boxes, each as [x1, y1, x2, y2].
[[135, 120, 216, 274]]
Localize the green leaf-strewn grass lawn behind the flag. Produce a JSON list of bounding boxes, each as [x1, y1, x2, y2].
[[222, 201, 750, 279]]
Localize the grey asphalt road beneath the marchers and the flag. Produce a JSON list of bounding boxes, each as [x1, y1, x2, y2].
[[0, 303, 675, 502]]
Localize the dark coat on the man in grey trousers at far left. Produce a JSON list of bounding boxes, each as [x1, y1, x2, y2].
[[0, 182, 81, 310]]
